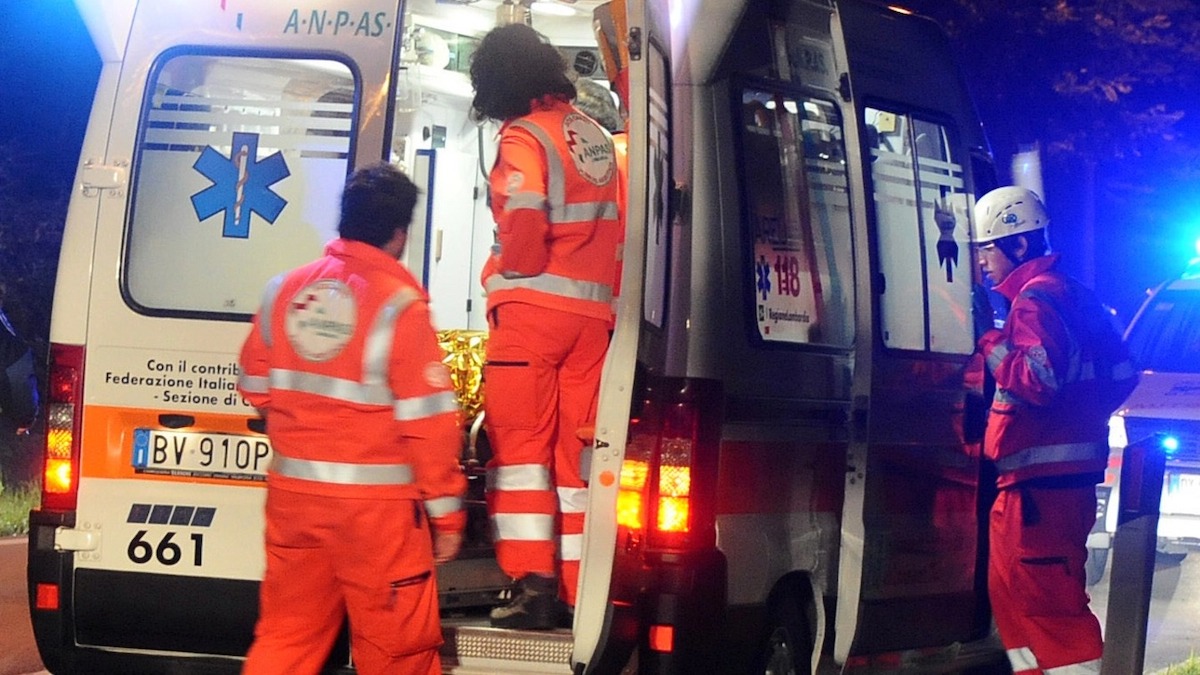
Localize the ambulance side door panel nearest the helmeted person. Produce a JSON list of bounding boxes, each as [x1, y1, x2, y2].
[[833, 0, 1002, 668]]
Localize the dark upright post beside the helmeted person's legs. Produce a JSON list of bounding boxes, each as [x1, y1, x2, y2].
[[1100, 435, 1166, 675]]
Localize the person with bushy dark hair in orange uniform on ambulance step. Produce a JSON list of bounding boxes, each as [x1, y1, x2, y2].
[[470, 24, 620, 629]]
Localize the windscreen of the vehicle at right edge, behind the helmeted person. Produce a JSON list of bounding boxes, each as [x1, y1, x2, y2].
[[1129, 283, 1200, 372]]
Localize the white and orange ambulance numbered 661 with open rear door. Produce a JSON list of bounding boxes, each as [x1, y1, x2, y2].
[[28, 0, 1008, 674]]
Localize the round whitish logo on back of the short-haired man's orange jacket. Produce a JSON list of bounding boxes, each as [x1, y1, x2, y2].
[[283, 279, 359, 362]]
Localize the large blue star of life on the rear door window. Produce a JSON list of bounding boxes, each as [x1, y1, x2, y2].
[[192, 132, 292, 239]]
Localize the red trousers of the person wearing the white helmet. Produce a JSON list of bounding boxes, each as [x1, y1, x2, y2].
[[988, 485, 1104, 675]]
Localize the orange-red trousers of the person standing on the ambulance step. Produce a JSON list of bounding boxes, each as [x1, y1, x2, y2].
[[484, 303, 608, 605]]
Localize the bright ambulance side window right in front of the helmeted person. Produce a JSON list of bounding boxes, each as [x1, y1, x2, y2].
[[865, 108, 974, 354]]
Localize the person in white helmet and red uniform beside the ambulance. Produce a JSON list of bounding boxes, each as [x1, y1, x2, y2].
[[973, 187, 1136, 675]]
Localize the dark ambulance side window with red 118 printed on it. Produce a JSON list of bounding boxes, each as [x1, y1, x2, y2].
[[738, 88, 854, 347]]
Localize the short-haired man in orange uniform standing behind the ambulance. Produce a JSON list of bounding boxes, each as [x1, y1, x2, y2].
[[239, 165, 466, 675]]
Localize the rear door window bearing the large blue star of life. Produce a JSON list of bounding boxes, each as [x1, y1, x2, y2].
[[121, 52, 358, 319]]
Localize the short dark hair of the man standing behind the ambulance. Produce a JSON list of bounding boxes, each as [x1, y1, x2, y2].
[[337, 162, 420, 246]]
